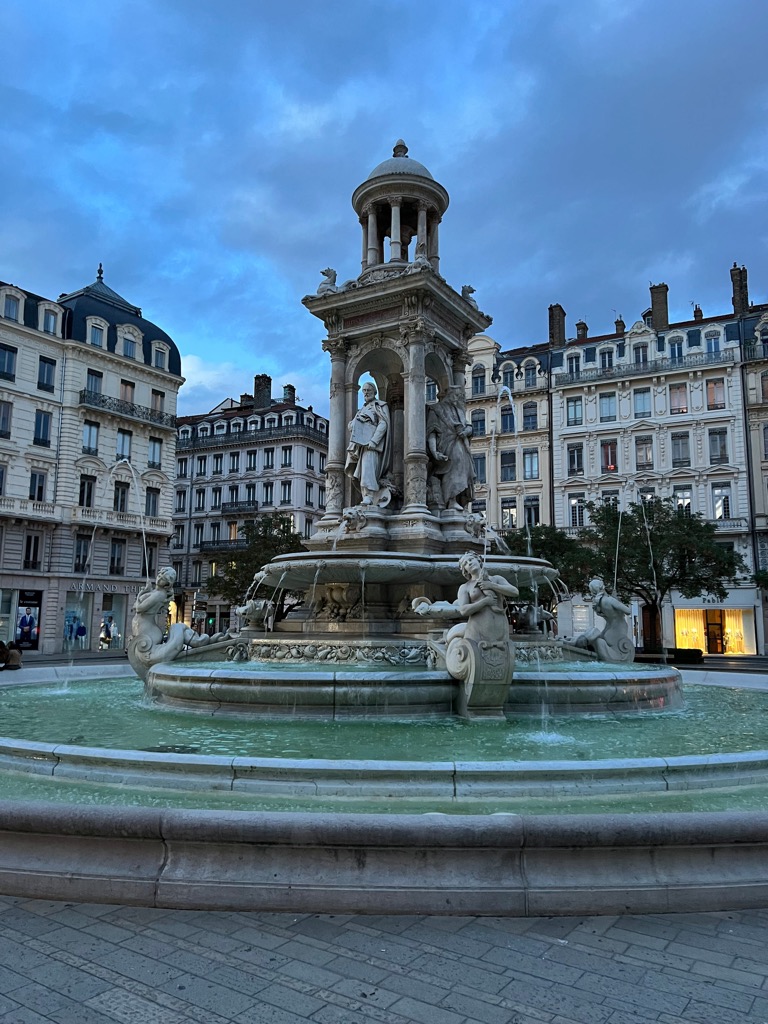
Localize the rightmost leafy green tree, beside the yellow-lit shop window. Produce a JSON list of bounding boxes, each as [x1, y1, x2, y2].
[[580, 498, 746, 646]]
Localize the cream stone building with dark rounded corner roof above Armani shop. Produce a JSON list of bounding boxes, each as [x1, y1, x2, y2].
[[0, 266, 182, 653]]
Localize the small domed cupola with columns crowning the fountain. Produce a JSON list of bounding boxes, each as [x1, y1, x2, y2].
[[352, 139, 450, 276]]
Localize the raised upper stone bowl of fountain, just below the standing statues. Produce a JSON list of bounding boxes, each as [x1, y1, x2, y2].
[[262, 551, 557, 590]]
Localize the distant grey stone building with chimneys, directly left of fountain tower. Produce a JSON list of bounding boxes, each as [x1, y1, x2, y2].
[[170, 374, 328, 633]]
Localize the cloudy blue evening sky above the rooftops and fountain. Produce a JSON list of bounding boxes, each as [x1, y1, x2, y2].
[[0, 0, 768, 414]]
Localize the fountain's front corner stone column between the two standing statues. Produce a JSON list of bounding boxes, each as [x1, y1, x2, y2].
[[401, 319, 429, 513]]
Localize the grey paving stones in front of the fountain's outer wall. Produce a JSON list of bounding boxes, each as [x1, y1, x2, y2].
[[0, 897, 768, 1024]]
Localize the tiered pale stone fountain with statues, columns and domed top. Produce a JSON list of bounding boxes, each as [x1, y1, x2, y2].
[[0, 142, 768, 914]]
